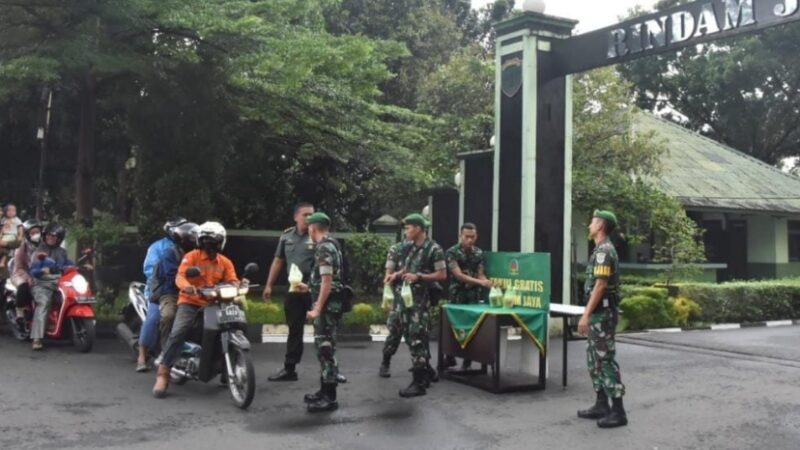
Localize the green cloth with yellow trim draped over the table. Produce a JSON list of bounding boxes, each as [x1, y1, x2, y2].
[[444, 304, 548, 355]]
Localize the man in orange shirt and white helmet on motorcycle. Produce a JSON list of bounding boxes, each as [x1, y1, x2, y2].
[[153, 222, 239, 398]]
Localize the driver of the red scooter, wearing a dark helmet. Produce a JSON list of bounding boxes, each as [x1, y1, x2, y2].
[[30, 222, 75, 350]]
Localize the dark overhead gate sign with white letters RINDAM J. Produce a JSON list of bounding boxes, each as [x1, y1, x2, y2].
[[550, 0, 800, 77]]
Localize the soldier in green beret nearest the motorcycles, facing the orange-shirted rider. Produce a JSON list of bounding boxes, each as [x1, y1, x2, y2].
[[296, 212, 343, 412]]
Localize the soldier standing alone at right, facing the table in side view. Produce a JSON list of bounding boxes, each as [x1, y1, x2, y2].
[[578, 210, 628, 428]]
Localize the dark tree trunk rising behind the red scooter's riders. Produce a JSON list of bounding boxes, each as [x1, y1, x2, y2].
[[75, 73, 97, 229]]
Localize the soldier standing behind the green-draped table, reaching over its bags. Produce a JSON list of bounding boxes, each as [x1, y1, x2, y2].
[[445, 223, 492, 370]]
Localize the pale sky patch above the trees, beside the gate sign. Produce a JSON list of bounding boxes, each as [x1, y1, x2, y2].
[[472, 0, 656, 33]]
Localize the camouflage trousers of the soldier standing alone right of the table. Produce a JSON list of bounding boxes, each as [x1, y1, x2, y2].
[[586, 308, 625, 398]]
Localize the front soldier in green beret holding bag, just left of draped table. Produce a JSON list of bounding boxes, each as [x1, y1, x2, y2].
[[392, 214, 447, 397]]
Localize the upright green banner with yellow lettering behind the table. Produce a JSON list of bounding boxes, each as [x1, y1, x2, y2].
[[485, 252, 550, 311]]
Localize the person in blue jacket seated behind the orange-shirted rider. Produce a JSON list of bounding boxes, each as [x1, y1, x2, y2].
[[136, 219, 197, 372]]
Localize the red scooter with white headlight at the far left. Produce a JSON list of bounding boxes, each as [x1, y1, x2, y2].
[[3, 250, 96, 353]]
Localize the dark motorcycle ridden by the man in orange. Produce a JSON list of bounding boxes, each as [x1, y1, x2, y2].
[[170, 263, 258, 409]]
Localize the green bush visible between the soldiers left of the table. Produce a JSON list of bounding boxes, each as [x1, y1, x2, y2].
[[344, 233, 392, 294]]
